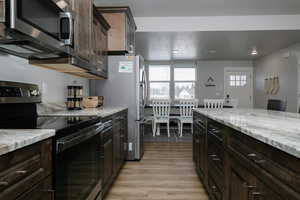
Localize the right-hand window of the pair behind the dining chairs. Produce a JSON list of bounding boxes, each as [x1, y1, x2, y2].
[[174, 68, 196, 99]]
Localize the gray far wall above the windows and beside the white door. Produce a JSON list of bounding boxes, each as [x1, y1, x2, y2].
[[147, 61, 253, 104]]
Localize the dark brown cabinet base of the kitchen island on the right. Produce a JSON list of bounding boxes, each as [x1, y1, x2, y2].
[[193, 112, 300, 200]]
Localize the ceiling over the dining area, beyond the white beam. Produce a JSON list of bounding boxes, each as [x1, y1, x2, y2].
[[136, 31, 300, 61]]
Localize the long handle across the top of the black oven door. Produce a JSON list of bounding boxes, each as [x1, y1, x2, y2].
[[56, 126, 104, 154]]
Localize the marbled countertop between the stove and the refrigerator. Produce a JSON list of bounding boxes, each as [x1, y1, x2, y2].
[[38, 107, 127, 118]]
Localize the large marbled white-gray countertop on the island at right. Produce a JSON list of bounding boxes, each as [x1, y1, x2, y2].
[[195, 109, 300, 158]]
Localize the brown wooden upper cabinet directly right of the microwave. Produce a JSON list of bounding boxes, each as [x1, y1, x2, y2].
[[29, 0, 110, 79]]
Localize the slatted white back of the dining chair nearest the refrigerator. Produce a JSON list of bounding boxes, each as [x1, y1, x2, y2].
[[152, 99, 171, 118]]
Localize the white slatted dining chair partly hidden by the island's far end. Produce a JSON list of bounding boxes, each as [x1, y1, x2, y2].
[[178, 99, 199, 137]]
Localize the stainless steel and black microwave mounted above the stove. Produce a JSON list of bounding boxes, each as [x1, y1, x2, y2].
[[0, 0, 74, 59]]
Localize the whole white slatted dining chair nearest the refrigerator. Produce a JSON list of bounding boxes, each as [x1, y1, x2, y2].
[[152, 99, 171, 137]]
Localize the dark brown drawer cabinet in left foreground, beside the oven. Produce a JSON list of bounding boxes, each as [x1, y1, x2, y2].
[[0, 139, 54, 200]]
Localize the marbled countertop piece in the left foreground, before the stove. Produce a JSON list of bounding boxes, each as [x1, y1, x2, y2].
[[0, 129, 55, 156]]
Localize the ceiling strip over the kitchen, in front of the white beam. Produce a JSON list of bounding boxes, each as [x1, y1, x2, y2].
[[94, 0, 300, 17]]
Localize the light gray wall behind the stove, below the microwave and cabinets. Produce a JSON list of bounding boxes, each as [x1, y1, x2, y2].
[[0, 55, 89, 103]]
